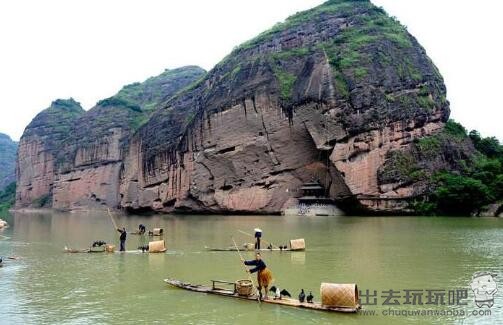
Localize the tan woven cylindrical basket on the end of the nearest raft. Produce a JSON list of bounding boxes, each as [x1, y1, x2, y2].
[[320, 283, 358, 308]]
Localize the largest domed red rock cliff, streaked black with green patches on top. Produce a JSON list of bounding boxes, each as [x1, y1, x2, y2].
[[120, 0, 449, 213]]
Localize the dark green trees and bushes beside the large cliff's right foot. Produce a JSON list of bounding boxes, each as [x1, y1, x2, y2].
[[405, 120, 503, 215]]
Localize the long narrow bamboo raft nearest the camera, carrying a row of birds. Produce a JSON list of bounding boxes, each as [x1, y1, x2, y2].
[[164, 279, 361, 313]]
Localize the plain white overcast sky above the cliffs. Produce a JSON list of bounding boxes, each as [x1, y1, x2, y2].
[[0, 0, 503, 140]]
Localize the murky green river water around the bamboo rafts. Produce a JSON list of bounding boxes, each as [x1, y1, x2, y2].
[[0, 212, 503, 324]]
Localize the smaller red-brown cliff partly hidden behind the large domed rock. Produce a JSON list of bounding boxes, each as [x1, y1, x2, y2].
[[16, 66, 205, 209]]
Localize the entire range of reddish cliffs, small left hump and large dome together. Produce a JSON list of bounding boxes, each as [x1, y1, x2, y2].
[[17, 0, 462, 213]]
